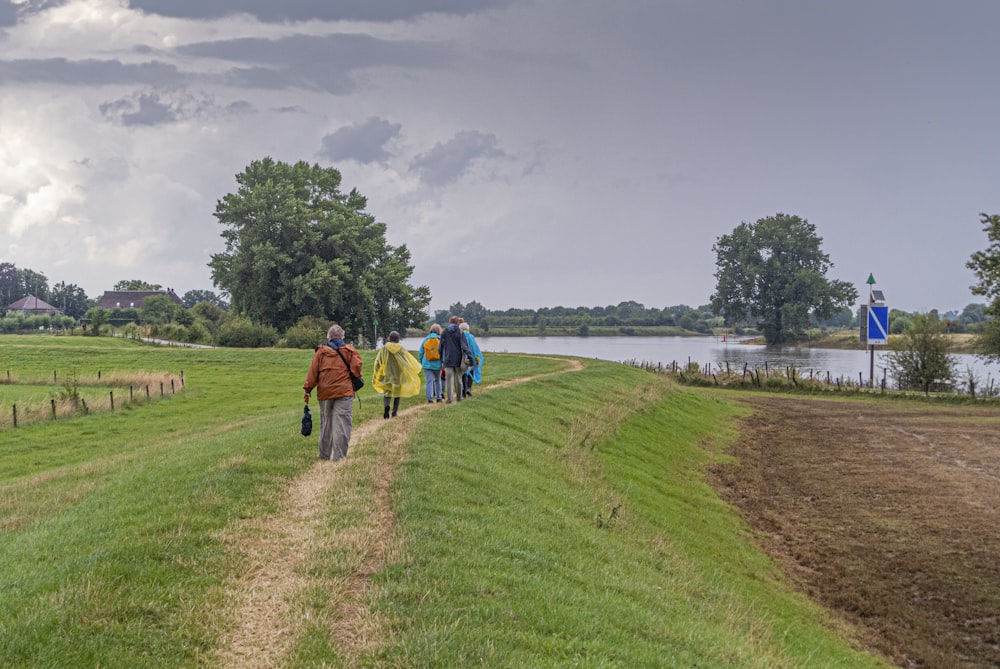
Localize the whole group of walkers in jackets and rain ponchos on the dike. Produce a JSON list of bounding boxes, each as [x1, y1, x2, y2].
[[302, 316, 483, 462]]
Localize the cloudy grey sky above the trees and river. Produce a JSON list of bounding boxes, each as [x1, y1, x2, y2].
[[0, 0, 1000, 313]]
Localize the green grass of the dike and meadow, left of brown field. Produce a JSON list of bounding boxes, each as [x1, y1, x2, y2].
[[0, 337, 885, 667]]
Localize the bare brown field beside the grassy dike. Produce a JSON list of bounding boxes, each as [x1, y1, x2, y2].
[[713, 395, 1000, 669]]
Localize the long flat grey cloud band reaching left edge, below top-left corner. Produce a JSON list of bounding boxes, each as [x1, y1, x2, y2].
[[0, 58, 183, 86]]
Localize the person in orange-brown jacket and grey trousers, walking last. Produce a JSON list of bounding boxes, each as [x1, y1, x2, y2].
[[302, 323, 361, 462]]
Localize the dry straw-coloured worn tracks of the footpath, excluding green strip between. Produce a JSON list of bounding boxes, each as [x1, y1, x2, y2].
[[218, 356, 584, 668]]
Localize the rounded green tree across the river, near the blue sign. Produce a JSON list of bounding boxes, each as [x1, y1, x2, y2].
[[711, 213, 858, 344]]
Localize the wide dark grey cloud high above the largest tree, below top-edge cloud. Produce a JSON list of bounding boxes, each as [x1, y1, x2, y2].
[[177, 34, 457, 95]]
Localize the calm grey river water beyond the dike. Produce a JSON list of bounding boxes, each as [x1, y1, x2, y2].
[[403, 336, 1000, 389]]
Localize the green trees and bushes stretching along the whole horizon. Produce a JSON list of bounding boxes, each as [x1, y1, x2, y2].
[[0, 157, 1000, 368]]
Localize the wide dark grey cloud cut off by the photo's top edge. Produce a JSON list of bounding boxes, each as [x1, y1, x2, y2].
[[131, 0, 513, 23]]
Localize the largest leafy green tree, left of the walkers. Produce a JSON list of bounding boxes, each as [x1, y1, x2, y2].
[[209, 158, 430, 338]]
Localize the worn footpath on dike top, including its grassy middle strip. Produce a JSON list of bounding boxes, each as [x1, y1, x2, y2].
[[218, 359, 583, 667]]
